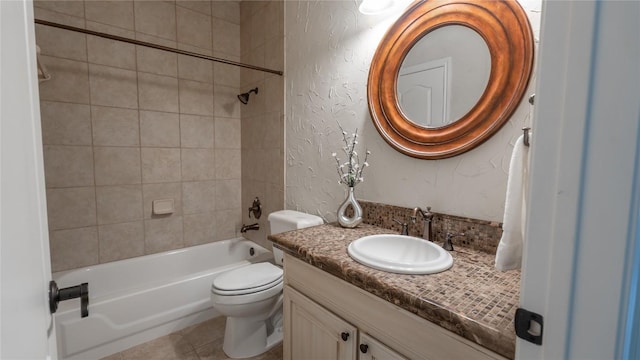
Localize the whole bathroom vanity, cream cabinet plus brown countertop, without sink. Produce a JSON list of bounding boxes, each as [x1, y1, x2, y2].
[[269, 224, 520, 359]]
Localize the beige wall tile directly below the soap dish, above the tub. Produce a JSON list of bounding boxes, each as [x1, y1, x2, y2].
[[144, 216, 184, 254]]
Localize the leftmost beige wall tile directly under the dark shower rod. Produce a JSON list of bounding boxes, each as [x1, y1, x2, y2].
[[36, 24, 87, 61]]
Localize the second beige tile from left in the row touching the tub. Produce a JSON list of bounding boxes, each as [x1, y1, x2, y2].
[[98, 221, 144, 263]]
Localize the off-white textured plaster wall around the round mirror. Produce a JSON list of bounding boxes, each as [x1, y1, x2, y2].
[[285, 0, 540, 221]]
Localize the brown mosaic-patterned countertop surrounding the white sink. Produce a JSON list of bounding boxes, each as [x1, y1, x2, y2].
[[269, 224, 520, 358]]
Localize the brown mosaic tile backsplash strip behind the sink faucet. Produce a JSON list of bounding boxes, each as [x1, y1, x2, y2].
[[358, 200, 502, 254]]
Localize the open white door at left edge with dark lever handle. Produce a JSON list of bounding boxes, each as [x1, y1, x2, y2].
[[0, 0, 56, 359]]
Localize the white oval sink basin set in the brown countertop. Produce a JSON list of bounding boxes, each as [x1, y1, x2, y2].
[[347, 234, 453, 274]]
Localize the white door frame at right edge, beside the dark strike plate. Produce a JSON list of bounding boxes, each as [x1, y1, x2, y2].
[[516, 1, 640, 359]]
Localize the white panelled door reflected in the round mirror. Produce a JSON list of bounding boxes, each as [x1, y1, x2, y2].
[[397, 57, 452, 128]]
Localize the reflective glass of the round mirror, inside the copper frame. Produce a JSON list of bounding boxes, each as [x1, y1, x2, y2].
[[397, 25, 491, 128]]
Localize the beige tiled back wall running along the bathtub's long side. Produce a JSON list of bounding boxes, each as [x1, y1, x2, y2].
[[35, 0, 245, 271]]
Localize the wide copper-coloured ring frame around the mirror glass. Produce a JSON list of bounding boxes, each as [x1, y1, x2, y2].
[[367, 0, 534, 159]]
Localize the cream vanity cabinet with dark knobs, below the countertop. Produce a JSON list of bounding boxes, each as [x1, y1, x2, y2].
[[283, 254, 506, 360]]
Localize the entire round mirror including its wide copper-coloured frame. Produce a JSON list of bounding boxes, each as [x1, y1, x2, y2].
[[367, 0, 533, 159]]
